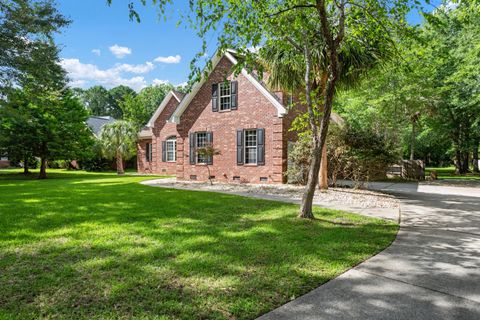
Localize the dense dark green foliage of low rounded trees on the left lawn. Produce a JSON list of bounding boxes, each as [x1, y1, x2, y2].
[[0, 88, 92, 178]]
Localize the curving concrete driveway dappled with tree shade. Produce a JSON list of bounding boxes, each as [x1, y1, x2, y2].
[[260, 183, 480, 320]]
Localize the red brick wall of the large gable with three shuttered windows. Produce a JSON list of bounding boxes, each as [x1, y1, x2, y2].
[[177, 57, 286, 183]]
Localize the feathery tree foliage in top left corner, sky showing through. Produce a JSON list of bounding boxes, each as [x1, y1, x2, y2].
[[0, 0, 70, 94]]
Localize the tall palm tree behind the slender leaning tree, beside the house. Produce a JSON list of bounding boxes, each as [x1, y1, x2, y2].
[[259, 42, 390, 190]]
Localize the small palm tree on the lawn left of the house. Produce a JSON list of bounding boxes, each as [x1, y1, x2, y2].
[[99, 120, 137, 174]]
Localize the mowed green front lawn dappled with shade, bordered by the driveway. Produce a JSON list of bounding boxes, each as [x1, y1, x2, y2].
[[0, 171, 398, 319]]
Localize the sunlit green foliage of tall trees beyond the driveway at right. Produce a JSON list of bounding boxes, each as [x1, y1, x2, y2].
[[336, 1, 480, 172]]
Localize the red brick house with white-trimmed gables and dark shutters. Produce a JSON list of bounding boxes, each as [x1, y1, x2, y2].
[[138, 51, 304, 183]]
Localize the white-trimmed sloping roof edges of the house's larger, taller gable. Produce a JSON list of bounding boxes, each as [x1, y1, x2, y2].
[[169, 50, 287, 123]]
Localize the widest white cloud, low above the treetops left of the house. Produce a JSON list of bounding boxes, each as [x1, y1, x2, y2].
[[60, 59, 148, 91]]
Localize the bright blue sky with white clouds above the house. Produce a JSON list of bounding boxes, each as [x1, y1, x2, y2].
[[57, 0, 432, 91]]
